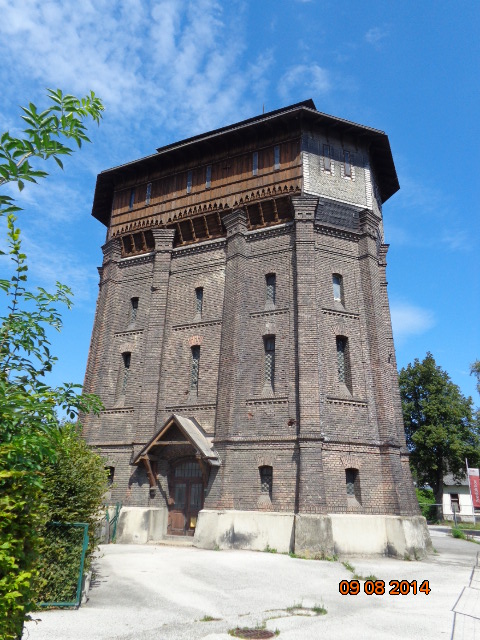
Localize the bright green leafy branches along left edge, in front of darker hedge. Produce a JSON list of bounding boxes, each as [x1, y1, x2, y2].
[[0, 90, 103, 640]]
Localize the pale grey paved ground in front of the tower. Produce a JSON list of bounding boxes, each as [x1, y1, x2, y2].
[[24, 529, 480, 640]]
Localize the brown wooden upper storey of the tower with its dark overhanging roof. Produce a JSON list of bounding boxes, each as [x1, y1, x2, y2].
[[92, 100, 398, 255]]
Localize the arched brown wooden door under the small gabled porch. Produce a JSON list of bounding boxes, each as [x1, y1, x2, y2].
[[167, 460, 204, 536]]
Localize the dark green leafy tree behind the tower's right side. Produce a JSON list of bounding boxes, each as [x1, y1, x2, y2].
[[399, 353, 480, 516]]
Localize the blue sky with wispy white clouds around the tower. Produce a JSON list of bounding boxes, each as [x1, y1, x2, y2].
[[0, 0, 480, 405]]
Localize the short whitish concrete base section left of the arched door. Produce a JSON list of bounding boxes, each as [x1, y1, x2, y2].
[[117, 507, 168, 544]]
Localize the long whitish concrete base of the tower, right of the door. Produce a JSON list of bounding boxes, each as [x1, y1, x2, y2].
[[194, 509, 432, 558]]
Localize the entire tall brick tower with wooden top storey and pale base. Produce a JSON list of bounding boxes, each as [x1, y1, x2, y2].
[[83, 100, 429, 556]]
